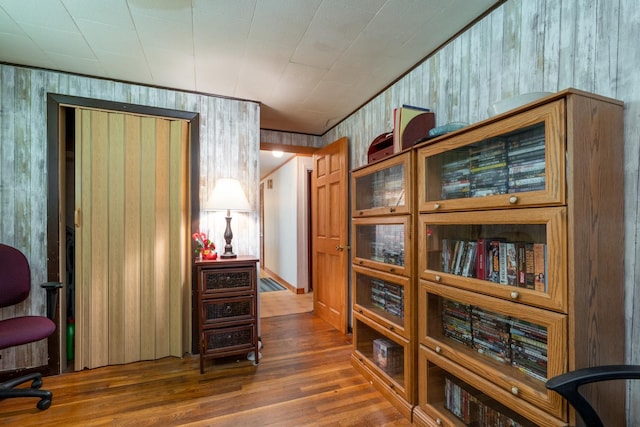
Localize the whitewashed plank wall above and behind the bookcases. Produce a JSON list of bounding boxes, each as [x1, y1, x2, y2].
[[322, 0, 640, 425]]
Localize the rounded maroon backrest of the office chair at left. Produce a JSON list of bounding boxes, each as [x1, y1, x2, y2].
[[0, 243, 31, 307]]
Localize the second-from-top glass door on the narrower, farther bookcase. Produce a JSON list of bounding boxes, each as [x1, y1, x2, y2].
[[352, 215, 411, 276]]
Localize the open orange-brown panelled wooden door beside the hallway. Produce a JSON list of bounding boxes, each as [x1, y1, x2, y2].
[[311, 138, 349, 333]]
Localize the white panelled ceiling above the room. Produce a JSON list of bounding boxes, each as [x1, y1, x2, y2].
[[0, 0, 500, 135]]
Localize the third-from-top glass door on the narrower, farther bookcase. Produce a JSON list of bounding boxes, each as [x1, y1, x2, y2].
[[352, 265, 413, 338]]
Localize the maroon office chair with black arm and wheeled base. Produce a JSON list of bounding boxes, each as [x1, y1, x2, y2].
[[0, 243, 62, 410]]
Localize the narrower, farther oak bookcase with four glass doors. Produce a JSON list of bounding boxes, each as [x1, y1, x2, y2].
[[351, 150, 417, 419]]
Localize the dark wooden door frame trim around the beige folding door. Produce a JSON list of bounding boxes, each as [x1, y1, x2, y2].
[[46, 93, 200, 374]]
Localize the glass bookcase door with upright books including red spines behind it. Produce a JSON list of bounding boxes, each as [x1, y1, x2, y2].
[[418, 207, 567, 313]]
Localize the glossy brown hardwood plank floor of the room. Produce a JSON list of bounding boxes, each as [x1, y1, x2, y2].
[[0, 313, 410, 427]]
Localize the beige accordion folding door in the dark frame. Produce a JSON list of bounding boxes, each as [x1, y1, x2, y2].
[[74, 109, 190, 370]]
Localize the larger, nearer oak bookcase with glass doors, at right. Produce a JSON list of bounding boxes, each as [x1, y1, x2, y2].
[[410, 89, 626, 426]]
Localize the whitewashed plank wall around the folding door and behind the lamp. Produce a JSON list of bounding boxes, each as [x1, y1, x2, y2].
[[0, 64, 260, 371]]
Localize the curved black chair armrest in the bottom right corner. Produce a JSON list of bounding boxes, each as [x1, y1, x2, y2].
[[546, 365, 640, 427]]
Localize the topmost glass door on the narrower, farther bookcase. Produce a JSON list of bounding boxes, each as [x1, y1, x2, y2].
[[351, 152, 412, 218]]
